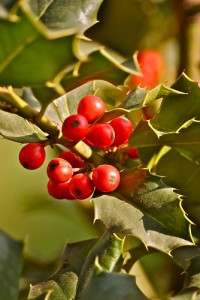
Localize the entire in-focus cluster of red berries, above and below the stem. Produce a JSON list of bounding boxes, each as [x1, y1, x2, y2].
[[19, 95, 138, 200]]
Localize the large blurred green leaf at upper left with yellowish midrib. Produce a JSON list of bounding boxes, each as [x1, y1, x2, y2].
[[0, 7, 77, 102]]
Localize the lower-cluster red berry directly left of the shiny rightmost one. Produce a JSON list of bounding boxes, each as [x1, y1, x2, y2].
[[69, 173, 94, 200]]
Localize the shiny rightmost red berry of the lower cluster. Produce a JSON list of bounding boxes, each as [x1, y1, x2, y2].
[[92, 165, 120, 192]]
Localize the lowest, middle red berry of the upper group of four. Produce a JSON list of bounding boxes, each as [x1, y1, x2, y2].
[[86, 123, 115, 149]]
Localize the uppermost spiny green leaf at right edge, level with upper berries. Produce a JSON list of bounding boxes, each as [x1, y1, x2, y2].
[[151, 73, 200, 135]]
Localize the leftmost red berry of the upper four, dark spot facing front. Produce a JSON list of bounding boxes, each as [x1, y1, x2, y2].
[[62, 114, 88, 142]]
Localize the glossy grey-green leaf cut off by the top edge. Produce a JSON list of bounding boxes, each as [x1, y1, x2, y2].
[[29, 0, 103, 33]]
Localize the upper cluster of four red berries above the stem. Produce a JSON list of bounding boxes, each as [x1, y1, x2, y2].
[[62, 95, 133, 149]]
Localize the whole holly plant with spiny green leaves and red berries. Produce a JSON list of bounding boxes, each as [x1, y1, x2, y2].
[[0, 0, 200, 300]]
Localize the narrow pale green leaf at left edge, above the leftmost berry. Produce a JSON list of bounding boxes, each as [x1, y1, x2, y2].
[[0, 110, 47, 143]]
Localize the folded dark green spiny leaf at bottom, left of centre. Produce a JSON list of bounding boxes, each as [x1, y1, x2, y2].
[[28, 232, 123, 300]]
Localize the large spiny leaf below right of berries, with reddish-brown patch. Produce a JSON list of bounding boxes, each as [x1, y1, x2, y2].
[[93, 169, 194, 253]]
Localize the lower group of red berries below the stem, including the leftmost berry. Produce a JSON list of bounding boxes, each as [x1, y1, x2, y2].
[[19, 143, 120, 200]]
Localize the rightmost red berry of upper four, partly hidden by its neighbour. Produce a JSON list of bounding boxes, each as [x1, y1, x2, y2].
[[109, 117, 133, 146]]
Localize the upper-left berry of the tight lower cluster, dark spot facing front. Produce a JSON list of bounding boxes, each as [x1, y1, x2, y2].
[[47, 157, 73, 183]]
